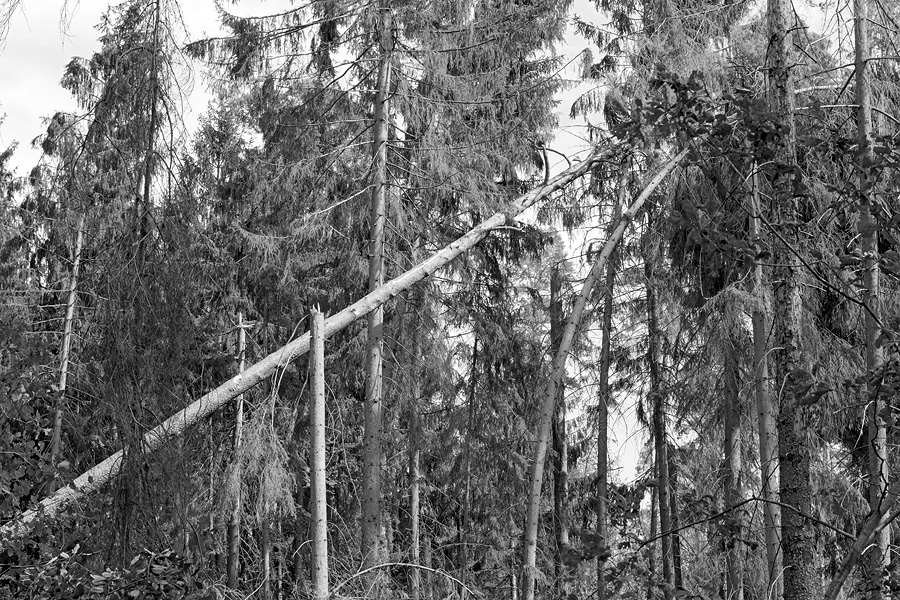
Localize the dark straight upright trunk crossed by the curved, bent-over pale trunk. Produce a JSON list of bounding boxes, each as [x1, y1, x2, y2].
[[550, 264, 569, 598]]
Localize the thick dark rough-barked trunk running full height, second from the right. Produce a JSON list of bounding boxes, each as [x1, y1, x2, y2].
[[767, 0, 819, 600]]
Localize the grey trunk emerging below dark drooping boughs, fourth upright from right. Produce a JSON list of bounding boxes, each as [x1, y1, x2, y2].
[[724, 344, 744, 600]]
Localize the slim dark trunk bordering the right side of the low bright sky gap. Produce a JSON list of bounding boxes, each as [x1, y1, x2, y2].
[[644, 215, 675, 600]]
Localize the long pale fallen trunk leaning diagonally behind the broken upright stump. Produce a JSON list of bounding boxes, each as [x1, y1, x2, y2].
[[0, 143, 615, 542]]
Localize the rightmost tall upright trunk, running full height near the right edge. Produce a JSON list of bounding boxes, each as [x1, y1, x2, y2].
[[853, 0, 891, 600]]
